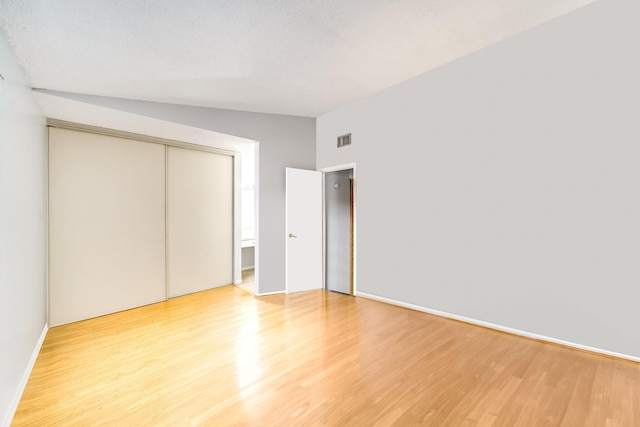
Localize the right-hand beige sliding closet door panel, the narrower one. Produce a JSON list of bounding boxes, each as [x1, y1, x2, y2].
[[167, 147, 233, 297]]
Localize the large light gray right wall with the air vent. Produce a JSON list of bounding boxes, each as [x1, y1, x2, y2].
[[317, 0, 640, 358]]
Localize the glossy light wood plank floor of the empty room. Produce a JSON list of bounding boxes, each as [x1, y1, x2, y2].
[[13, 286, 640, 427]]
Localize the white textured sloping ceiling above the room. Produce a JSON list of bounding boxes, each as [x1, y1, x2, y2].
[[0, 0, 593, 117]]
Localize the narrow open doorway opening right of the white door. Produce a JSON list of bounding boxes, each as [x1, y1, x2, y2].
[[324, 168, 355, 295]]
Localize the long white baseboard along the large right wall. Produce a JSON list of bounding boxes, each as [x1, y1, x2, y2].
[[358, 292, 640, 362]]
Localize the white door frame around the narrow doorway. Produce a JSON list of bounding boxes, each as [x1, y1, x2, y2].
[[318, 162, 358, 296]]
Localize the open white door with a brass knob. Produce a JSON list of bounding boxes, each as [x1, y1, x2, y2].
[[286, 168, 322, 293]]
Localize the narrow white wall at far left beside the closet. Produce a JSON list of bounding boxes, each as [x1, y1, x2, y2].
[[0, 34, 47, 425]]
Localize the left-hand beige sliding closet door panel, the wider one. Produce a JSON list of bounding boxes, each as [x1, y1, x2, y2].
[[49, 128, 166, 326]]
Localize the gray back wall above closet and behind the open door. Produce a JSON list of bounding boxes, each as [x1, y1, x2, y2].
[[34, 92, 316, 293]]
